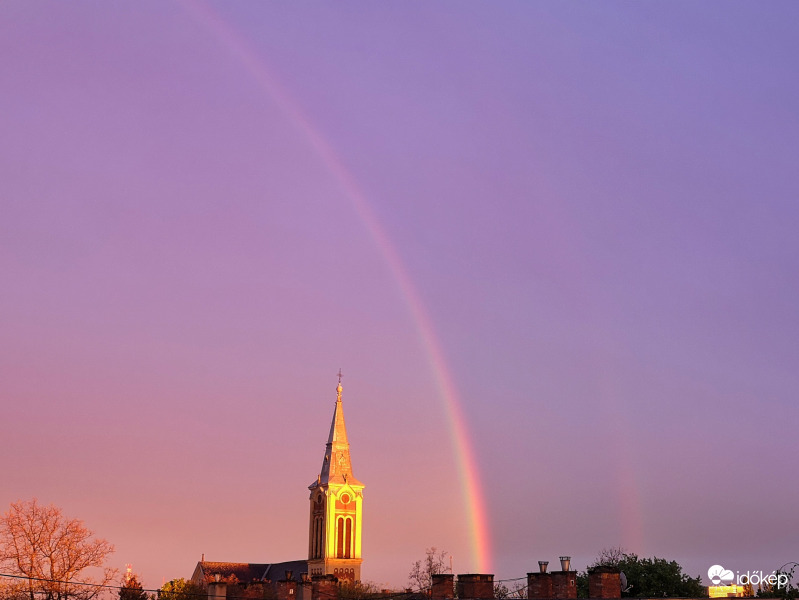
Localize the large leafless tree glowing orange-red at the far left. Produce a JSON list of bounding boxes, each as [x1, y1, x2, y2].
[[0, 499, 117, 600]]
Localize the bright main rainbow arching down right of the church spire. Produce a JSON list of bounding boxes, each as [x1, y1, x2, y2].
[[178, 0, 492, 573]]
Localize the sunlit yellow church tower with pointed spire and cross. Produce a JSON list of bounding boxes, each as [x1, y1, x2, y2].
[[308, 371, 364, 581]]
